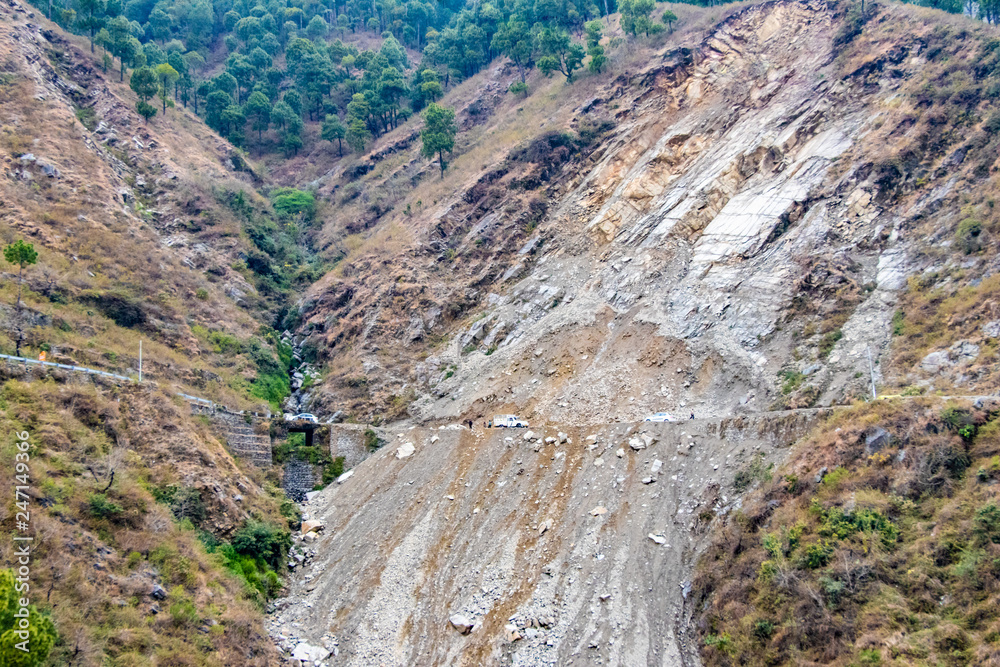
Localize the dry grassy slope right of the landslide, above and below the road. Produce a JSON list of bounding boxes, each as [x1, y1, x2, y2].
[[694, 6, 1000, 665]]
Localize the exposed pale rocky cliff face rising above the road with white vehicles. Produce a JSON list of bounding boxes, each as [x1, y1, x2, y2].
[[303, 2, 996, 423]]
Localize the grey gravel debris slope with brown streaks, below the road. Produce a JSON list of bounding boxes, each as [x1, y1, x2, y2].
[[270, 411, 822, 666]]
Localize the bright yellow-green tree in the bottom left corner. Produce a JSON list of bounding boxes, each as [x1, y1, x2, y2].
[[0, 569, 56, 667]]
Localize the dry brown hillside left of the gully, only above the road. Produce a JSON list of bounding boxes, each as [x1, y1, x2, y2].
[[0, 3, 304, 407]]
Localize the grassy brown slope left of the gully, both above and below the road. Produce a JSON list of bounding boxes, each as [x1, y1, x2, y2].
[[0, 6, 300, 665]]
